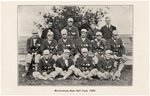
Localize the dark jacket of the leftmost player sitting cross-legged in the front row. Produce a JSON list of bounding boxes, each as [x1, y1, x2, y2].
[[38, 57, 55, 73]]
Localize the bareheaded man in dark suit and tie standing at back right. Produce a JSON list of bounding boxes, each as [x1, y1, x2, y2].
[[101, 17, 116, 40]]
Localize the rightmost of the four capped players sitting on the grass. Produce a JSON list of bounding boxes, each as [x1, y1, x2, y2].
[[96, 50, 117, 79]]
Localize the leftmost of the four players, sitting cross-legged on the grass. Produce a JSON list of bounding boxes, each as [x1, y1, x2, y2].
[[33, 50, 58, 80]]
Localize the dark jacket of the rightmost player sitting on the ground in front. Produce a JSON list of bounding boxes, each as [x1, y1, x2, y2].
[[96, 57, 116, 72]]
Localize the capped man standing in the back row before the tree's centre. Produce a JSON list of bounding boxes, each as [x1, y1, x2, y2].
[[64, 18, 79, 40]]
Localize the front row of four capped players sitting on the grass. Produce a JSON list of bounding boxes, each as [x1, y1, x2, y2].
[[32, 48, 126, 80]]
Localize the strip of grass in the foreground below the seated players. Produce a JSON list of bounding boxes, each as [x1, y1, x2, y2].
[[18, 65, 132, 86]]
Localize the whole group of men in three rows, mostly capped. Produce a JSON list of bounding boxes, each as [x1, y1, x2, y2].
[[24, 17, 127, 80]]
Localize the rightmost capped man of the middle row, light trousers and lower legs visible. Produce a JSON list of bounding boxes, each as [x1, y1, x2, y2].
[[107, 30, 127, 78]]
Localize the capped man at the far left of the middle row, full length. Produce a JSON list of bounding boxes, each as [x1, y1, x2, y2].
[[23, 30, 42, 76]]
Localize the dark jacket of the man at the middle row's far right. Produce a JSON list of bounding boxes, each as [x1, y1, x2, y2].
[[107, 38, 125, 57]]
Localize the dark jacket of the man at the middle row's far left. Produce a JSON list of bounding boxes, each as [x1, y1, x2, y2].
[[26, 37, 42, 54]]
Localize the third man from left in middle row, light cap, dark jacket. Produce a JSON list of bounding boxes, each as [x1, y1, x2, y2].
[[57, 29, 75, 55]]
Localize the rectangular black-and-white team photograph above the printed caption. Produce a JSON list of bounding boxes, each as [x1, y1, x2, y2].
[[17, 5, 134, 86]]
